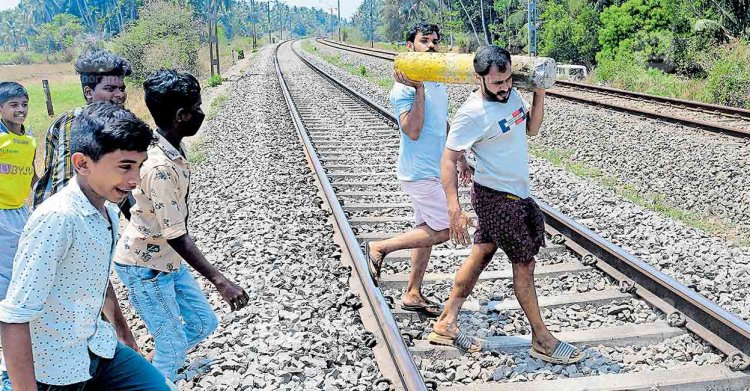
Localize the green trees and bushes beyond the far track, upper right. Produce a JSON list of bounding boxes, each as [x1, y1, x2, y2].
[[352, 0, 750, 108]]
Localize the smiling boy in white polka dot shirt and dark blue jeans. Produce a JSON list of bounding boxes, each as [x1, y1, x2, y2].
[[0, 108, 176, 391]]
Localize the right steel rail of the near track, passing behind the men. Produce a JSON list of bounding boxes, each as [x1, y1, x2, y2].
[[295, 39, 750, 370]]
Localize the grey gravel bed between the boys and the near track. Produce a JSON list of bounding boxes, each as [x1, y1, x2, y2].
[[118, 47, 388, 391]]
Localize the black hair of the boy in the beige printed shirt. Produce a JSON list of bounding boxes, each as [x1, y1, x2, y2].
[[143, 69, 201, 128]]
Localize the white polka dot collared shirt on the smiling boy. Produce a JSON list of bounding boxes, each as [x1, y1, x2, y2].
[[0, 178, 118, 385]]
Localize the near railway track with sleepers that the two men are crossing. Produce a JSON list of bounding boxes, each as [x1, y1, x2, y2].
[[276, 42, 750, 391]]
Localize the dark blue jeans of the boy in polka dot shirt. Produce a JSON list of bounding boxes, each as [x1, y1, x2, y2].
[[37, 342, 178, 391]]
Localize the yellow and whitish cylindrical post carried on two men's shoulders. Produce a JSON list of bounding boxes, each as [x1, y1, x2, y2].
[[393, 52, 557, 89]]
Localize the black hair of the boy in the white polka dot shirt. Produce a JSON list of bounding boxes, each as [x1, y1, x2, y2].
[[70, 113, 154, 161]]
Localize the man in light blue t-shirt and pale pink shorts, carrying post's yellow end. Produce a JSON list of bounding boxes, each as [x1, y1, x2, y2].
[[365, 22, 469, 317]]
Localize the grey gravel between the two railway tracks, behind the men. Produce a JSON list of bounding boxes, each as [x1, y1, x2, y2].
[[302, 42, 750, 320]]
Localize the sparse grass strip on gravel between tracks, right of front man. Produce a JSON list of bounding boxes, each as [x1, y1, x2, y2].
[[529, 144, 750, 246]]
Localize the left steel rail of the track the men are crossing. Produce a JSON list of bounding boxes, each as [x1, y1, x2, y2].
[[274, 41, 427, 391]]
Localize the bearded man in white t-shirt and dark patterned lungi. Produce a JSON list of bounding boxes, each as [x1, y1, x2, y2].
[[428, 46, 583, 364]]
